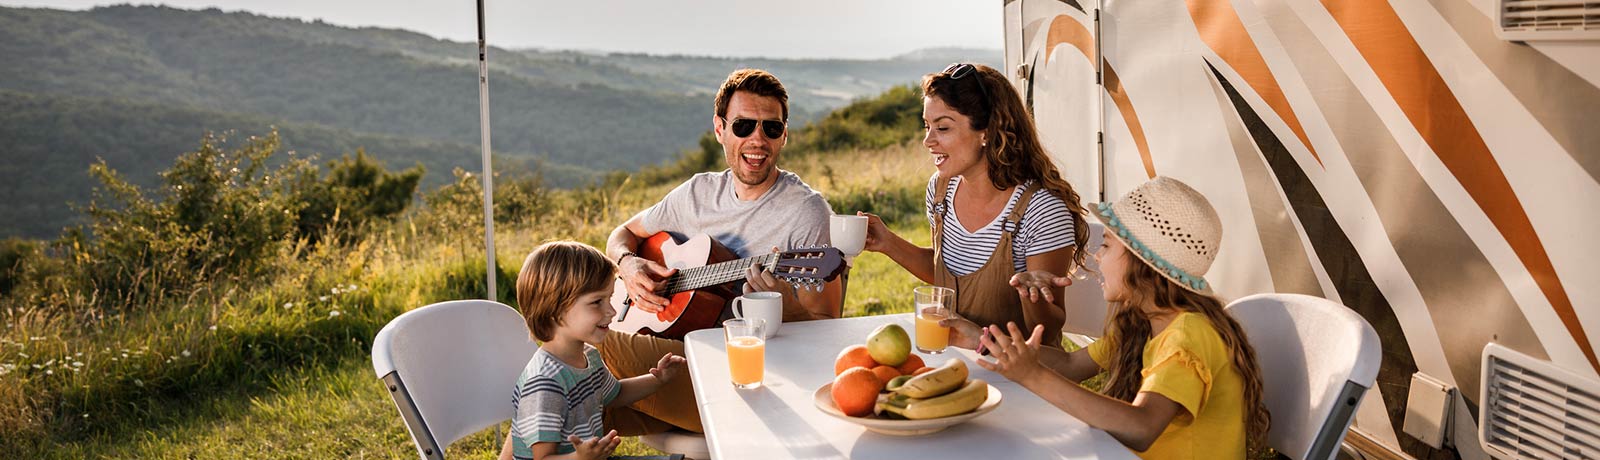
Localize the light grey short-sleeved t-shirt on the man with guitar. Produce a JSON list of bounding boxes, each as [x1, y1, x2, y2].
[[640, 169, 834, 259]]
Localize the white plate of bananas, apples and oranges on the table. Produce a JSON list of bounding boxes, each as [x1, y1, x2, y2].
[[811, 324, 1002, 436]]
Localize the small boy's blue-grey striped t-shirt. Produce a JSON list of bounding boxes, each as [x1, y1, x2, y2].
[[510, 345, 622, 458]]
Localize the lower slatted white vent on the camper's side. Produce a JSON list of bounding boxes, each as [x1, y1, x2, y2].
[[1478, 343, 1600, 458]]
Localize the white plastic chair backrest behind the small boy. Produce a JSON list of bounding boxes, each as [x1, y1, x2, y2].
[[373, 300, 538, 458]]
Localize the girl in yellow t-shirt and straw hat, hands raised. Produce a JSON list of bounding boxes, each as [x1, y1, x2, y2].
[[978, 177, 1270, 458]]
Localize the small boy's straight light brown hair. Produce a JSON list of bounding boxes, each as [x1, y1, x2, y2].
[[517, 241, 616, 342]]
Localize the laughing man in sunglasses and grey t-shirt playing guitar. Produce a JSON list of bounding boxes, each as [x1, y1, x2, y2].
[[600, 69, 843, 436]]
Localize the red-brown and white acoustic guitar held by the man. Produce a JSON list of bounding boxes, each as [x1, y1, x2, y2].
[[611, 232, 845, 340]]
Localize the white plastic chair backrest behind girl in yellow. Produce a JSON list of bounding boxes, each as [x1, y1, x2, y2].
[[1227, 294, 1382, 460]]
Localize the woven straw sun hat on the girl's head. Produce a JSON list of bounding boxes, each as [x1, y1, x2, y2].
[[1091, 176, 1222, 294]]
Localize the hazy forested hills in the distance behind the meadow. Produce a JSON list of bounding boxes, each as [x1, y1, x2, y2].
[[0, 5, 1000, 238]]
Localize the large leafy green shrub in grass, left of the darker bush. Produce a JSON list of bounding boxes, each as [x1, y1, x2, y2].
[[70, 133, 314, 305]]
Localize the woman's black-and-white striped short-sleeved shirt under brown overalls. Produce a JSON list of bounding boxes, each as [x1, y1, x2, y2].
[[925, 173, 1077, 276]]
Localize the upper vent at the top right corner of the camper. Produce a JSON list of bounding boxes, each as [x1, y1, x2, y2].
[[1499, 0, 1600, 42]]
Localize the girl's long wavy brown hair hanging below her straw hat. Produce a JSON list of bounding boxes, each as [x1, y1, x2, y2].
[[1101, 247, 1272, 454]]
